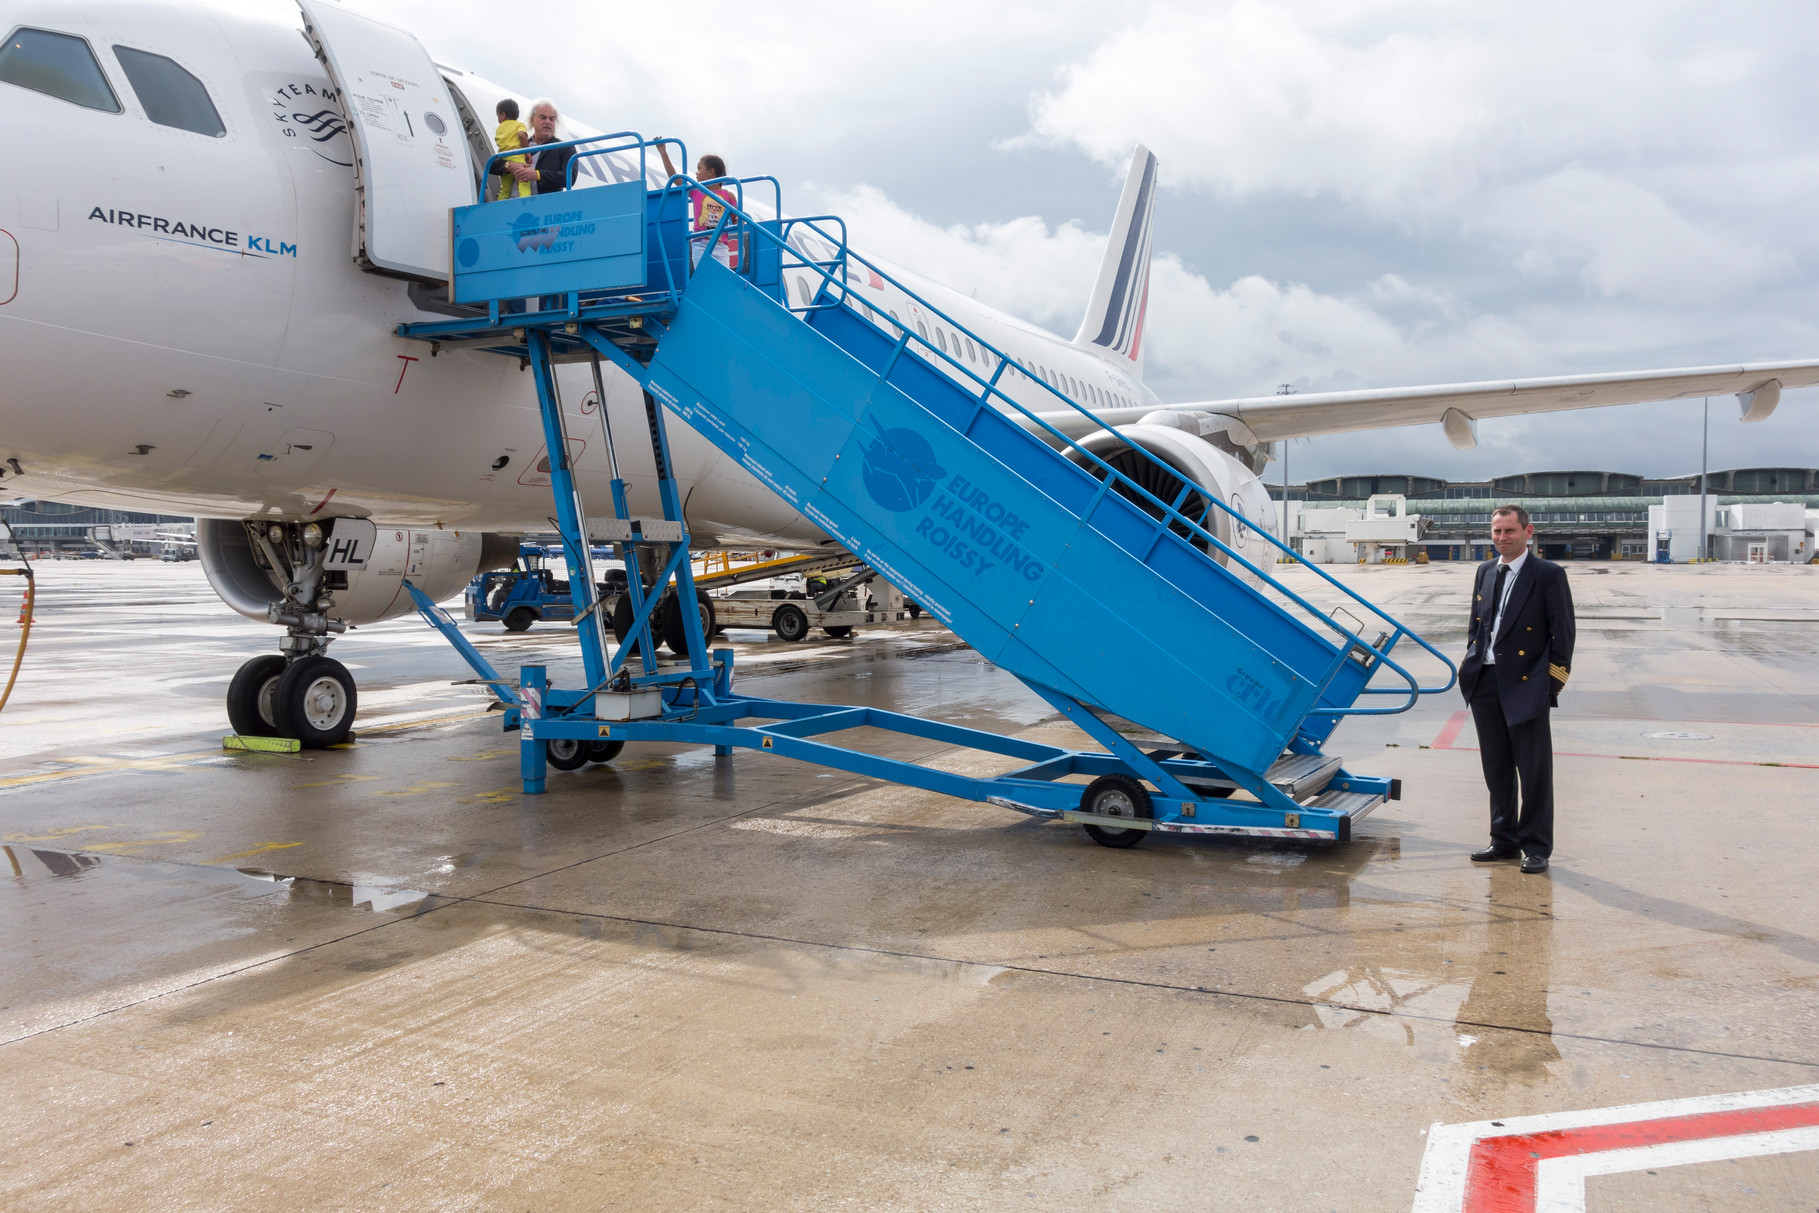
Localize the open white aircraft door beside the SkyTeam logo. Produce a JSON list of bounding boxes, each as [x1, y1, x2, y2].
[[298, 0, 473, 282]]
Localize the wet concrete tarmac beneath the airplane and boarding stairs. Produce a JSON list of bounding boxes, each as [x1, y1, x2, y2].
[[0, 562, 1819, 1211]]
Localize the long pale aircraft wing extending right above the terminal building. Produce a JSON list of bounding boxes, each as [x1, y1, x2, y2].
[[1042, 362, 1819, 449]]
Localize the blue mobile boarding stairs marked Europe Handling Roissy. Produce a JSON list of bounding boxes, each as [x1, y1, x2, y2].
[[398, 133, 1453, 846]]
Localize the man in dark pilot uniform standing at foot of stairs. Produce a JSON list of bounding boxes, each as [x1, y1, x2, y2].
[[1459, 506, 1573, 873]]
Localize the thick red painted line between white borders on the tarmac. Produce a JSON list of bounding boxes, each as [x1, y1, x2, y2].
[[1462, 1104, 1819, 1213]]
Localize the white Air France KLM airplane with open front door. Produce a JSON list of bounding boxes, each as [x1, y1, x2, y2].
[[0, 0, 1819, 744]]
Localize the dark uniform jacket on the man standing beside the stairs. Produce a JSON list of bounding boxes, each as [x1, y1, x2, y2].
[[1459, 553, 1573, 724]]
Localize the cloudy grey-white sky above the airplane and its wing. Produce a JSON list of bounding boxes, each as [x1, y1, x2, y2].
[[372, 0, 1819, 482]]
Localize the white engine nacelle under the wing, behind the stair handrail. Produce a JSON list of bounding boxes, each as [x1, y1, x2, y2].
[[1068, 422, 1281, 569]]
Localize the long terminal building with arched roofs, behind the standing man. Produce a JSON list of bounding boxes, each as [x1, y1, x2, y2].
[[1270, 467, 1819, 564]]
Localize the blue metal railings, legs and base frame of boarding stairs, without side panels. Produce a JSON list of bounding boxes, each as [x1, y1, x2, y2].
[[398, 133, 1453, 840]]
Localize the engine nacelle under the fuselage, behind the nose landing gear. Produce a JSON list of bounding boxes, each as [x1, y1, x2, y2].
[[196, 518, 518, 624]]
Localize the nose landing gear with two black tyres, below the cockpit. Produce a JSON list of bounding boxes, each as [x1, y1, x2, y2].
[[227, 522, 360, 749]]
